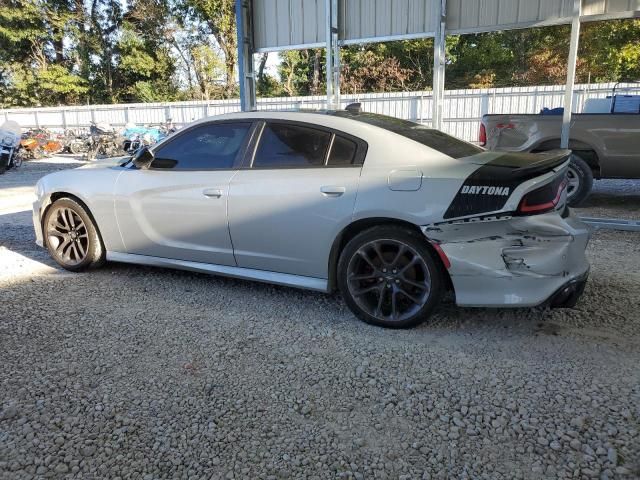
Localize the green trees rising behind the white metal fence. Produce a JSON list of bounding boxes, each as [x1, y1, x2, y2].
[[0, 0, 640, 106]]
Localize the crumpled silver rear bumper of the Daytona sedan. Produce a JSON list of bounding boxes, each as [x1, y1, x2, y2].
[[423, 212, 591, 307]]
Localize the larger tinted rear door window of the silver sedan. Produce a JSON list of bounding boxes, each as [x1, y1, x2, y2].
[[253, 123, 331, 168]]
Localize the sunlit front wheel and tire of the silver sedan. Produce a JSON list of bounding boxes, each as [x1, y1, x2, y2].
[[43, 198, 105, 272]]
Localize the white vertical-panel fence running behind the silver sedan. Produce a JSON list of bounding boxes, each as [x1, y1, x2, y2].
[[0, 83, 632, 141]]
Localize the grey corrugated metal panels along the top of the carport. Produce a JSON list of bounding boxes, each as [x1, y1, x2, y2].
[[253, 0, 640, 51]]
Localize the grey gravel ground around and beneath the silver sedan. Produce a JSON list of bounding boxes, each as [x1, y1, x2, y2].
[[0, 161, 640, 479]]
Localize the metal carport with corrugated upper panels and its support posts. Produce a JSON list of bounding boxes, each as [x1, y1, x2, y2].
[[236, 0, 640, 146]]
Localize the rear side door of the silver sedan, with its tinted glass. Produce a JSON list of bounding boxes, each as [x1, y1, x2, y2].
[[229, 121, 366, 278]]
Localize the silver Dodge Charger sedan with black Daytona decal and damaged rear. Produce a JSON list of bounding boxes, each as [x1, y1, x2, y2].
[[33, 105, 589, 327]]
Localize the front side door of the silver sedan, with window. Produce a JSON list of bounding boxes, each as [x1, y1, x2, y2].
[[115, 121, 253, 266]]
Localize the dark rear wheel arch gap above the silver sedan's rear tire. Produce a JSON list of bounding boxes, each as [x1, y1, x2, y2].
[[328, 217, 453, 291]]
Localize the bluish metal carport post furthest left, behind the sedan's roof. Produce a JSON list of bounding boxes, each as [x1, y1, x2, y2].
[[236, 0, 257, 112]]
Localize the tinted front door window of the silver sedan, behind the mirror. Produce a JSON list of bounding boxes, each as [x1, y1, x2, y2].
[[151, 123, 251, 170]]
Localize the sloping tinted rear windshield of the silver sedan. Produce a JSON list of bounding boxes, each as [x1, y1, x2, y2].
[[334, 111, 484, 158]]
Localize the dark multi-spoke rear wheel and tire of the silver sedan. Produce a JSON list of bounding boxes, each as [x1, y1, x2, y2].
[[337, 225, 444, 328]]
